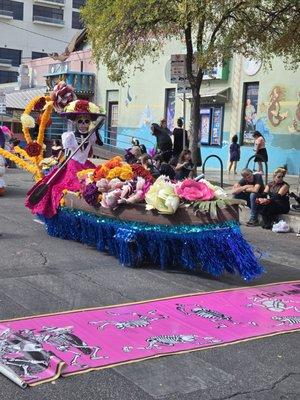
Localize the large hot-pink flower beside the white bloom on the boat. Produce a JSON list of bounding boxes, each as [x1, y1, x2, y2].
[[176, 179, 215, 201]]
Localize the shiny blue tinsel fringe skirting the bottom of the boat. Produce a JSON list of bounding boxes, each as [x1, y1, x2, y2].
[[44, 208, 264, 281]]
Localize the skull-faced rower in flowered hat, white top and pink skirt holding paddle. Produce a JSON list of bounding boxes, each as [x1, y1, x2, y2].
[[25, 100, 101, 218]]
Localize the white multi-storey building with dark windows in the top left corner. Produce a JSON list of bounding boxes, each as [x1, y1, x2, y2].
[[0, 0, 85, 84]]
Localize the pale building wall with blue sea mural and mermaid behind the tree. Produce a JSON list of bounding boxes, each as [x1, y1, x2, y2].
[[96, 42, 300, 175]]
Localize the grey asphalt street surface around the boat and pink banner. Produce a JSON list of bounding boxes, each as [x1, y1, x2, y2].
[[0, 169, 300, 400]]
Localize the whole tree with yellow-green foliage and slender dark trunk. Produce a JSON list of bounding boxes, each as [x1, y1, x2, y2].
[[81, 0, 300, 165]]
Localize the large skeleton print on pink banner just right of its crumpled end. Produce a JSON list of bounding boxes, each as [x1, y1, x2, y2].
[[38, 326, 108, 367]]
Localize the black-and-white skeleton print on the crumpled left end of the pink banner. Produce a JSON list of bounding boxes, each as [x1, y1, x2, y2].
[[0, 329, 54, 379]]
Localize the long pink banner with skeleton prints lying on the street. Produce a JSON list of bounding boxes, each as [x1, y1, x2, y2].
[[0, 281, 300, 385]]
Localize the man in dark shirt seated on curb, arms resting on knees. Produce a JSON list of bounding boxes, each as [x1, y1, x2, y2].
[[232, 168, 264, 226]]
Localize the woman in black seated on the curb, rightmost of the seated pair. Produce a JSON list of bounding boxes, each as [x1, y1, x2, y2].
[[256, 168, 290, 229]]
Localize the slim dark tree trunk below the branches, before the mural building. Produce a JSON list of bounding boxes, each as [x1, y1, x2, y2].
[[189, 87, 202, 166]]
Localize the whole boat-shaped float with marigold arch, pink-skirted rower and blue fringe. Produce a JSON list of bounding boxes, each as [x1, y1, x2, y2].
[[0, 82, 263, 280]]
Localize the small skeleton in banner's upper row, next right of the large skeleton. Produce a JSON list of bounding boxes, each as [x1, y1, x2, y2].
[[89, 310, 169, 330]]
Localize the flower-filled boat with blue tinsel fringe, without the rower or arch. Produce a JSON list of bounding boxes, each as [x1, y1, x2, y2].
[[44, 157, 263, 280]]
